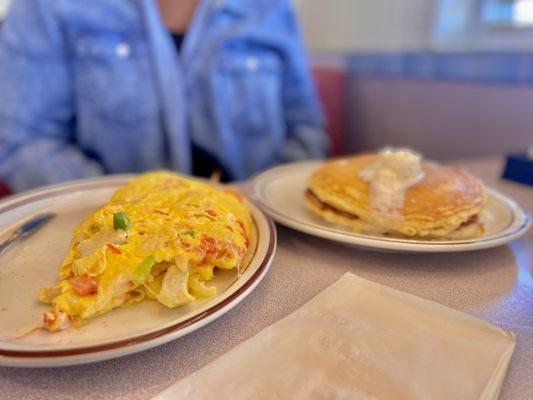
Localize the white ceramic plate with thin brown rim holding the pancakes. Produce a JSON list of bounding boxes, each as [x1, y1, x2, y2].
[[249, 161, 531, 252]]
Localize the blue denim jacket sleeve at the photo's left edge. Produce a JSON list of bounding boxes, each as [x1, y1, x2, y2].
[[0, 0, 103, 191]]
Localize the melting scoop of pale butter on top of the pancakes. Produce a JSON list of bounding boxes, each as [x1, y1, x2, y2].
[[359, 148, 424, 218]]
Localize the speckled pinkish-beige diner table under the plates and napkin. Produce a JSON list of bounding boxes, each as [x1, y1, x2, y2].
[[0, 159, 533, 400]]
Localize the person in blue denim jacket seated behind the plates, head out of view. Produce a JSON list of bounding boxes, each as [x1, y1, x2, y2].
[[0, 0, 328, 191]]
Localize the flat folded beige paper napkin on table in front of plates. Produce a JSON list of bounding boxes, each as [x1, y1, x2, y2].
[[156, 273, 515, 400]]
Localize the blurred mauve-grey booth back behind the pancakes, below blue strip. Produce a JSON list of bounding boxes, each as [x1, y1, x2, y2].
[[345, 76, 533, 160]]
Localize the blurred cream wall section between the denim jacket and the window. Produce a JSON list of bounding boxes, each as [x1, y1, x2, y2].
[[296, 0, 435, 53]]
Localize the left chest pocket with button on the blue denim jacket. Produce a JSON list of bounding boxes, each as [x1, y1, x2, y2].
[[72, 33, 158, 127]]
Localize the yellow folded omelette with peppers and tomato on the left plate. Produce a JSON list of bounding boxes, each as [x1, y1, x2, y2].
[[39, 171, 252, 331]]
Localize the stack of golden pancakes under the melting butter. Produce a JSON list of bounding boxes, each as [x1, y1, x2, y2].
[[305, 154, 486, 239]]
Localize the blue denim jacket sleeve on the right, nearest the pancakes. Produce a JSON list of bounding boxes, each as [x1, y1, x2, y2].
[[278, 0, 330, 162]]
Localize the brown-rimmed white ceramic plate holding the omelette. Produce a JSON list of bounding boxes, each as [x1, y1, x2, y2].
[[0, 176, 276, 367]]
